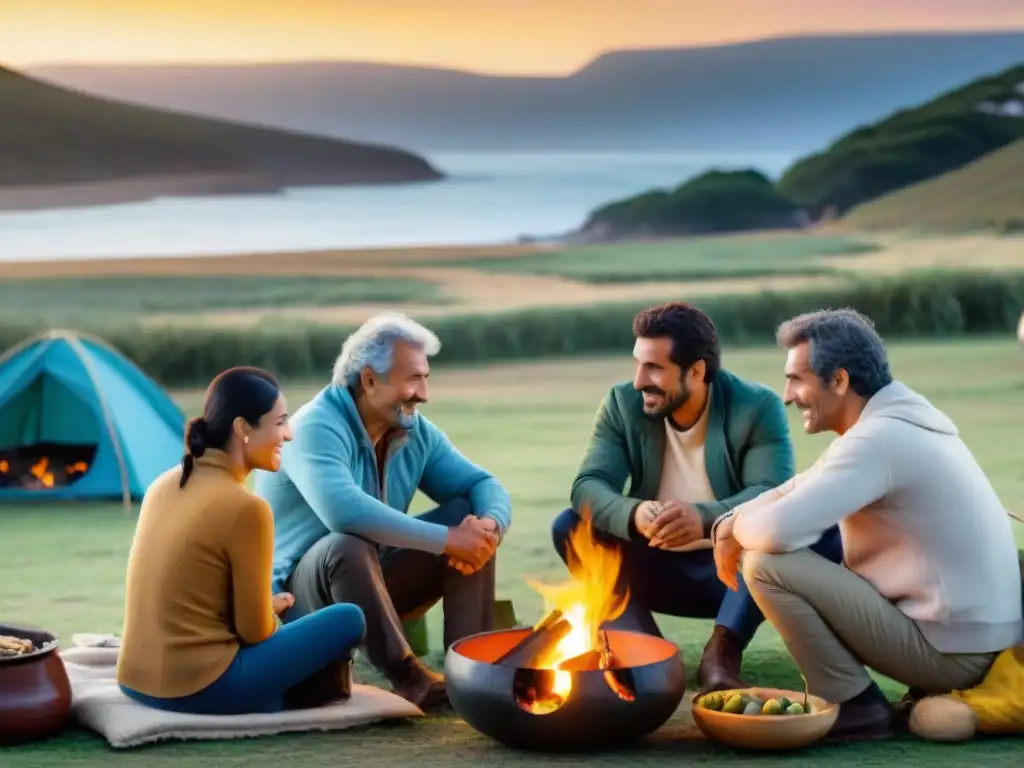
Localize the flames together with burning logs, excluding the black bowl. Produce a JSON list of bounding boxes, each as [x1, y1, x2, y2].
[[497, 514, 633, 714]]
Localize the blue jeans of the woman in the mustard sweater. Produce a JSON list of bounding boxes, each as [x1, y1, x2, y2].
[[121, 603, 366, 715]]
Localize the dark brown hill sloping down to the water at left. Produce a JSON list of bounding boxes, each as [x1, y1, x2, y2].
[[0, 68, 440, 195]]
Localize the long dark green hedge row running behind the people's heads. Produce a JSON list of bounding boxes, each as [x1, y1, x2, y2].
[[0, 272, 1024, 386]]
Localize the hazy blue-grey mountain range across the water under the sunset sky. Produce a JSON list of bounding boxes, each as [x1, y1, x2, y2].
[[25, 32, 1024, 153]]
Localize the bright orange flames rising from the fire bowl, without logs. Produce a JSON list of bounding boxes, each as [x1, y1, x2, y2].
[[527, 510, 629, 712]]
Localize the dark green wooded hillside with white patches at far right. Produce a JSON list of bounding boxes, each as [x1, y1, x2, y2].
[[778, 63, 1024, 217]]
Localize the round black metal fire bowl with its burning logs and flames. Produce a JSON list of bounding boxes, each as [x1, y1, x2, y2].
[[444, 507, 686, 750]]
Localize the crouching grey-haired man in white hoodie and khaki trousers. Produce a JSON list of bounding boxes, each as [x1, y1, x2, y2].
[[712, 309, 1024, 740]]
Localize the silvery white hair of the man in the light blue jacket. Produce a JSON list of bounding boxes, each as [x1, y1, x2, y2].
[[332, 312, 441, 387]]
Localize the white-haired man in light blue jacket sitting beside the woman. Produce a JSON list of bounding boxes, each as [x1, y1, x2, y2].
[[255, 312, 511, 710]]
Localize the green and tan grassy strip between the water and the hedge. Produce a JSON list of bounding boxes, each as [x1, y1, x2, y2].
[[0, 230, 1022, 328]]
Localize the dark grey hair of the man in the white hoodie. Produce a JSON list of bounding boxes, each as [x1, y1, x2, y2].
[[775, 309, 893, 397]]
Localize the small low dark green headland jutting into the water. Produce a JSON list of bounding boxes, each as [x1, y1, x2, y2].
[[580, 170, 803, 241]]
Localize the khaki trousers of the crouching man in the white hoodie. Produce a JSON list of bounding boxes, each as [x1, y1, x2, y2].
[[742, 550, 996, 702]]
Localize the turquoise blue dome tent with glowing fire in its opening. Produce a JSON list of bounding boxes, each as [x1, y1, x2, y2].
[[0, 331, 185, 504]]
